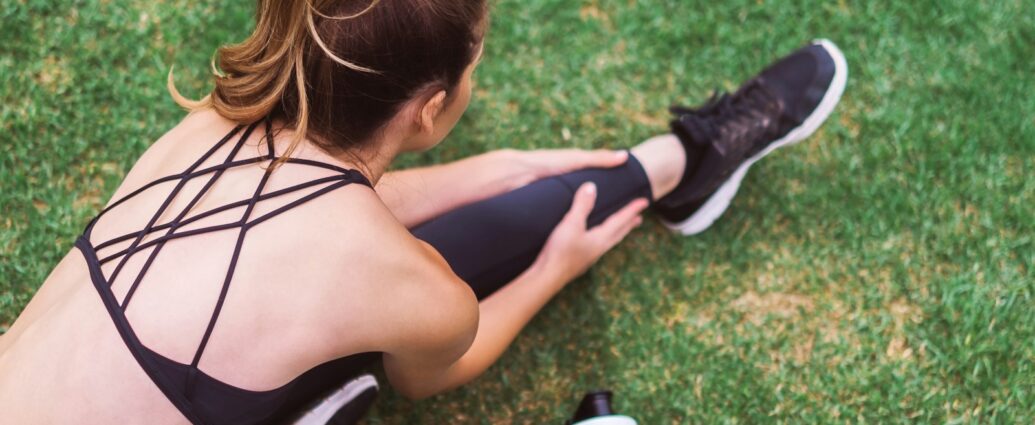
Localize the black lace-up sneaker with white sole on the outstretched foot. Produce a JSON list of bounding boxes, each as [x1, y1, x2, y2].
[[653, 39, 848, 235]]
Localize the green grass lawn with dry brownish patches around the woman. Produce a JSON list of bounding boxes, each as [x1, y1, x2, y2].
[[0, 0, 1035, 424]]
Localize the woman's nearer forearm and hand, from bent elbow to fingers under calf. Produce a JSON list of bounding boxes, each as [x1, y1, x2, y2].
[[385, 184, 647, 398]]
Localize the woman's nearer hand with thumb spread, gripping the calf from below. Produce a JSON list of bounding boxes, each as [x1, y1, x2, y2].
[[532, 183, 648, 289]]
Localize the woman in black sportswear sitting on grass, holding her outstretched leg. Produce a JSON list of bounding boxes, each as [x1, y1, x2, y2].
[[0, 0, 847, 424]]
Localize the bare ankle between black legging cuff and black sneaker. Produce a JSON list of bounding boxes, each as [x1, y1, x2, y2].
[[629, 133, 686, 201]]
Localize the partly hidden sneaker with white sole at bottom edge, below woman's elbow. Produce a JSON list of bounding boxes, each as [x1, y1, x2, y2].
[[293, 373, 378, 425]]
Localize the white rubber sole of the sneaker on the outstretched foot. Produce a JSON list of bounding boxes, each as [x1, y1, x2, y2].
[[661, 39, 848, 235]]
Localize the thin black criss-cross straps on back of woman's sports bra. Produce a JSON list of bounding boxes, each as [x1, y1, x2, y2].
[[76, 118, 372, 423]]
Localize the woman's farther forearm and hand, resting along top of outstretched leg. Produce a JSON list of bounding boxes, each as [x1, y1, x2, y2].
[[375, 149, 627, 227]]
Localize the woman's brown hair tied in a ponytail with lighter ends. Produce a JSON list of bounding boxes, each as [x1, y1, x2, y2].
[[168, 0, 486, 164]]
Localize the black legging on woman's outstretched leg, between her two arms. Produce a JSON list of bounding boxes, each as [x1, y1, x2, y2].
[[413, 155, 651, 300]]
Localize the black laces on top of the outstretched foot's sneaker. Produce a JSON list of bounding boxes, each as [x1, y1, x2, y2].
[[669, 80, 782, 156]]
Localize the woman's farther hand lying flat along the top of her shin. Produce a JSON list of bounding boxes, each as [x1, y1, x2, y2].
[[486, 149, 629, 191]]
